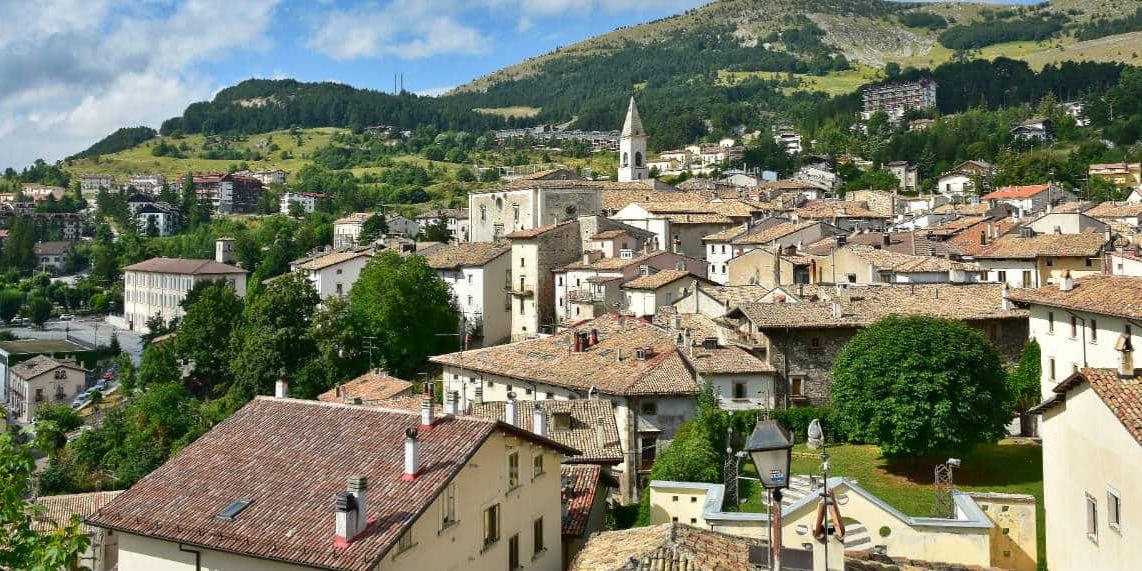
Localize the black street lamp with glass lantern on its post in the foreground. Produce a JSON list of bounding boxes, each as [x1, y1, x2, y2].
[[746, 420, 793, 571]]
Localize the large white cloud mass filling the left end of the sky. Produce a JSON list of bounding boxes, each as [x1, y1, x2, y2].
[[0, 0, 278, 168]]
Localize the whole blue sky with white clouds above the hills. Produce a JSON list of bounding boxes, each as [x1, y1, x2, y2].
[[0, 0, 708, 169]]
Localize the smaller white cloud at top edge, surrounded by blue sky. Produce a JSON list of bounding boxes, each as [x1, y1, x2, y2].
[[307, 0, 490, 59]]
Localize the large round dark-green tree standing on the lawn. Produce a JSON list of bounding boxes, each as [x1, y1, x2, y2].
[[833, 315, 1011, 456]]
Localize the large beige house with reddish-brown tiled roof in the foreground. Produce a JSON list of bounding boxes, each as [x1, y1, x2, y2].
[[88, 397, 574, 571]]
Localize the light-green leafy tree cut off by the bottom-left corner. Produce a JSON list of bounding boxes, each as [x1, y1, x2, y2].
[[0, 431, 88, 571]]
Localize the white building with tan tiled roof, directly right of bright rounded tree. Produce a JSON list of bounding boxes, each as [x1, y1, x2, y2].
[[426, 242, 512, 347]]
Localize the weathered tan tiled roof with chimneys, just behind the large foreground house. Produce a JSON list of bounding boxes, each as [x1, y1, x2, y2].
[[471, 399, 622, 464]]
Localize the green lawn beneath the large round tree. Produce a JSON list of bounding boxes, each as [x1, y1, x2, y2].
[[741, 441, 1046, 562]]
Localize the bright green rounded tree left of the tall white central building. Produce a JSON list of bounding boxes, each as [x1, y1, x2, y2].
[[349, 250, 458, 375]]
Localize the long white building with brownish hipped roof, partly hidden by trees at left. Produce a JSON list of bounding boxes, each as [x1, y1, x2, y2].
[[123, 253, 246, 333]]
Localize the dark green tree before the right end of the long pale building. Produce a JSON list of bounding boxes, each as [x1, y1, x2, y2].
[[175, 280, 242, 395]]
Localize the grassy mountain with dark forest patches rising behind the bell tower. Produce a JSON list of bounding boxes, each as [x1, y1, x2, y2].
[[447, 0, 1142, 139]]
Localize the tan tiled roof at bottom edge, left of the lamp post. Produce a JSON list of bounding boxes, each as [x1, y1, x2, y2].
[[569, 523, 762, 571]]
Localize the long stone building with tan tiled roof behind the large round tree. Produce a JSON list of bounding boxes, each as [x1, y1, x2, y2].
[[724, 284, 1028, 407]]
